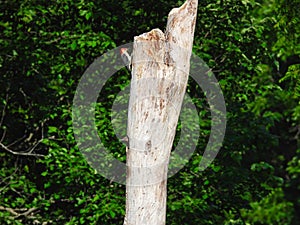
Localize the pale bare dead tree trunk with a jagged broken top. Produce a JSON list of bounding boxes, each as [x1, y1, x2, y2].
[[124, 0, 198, 225]]
